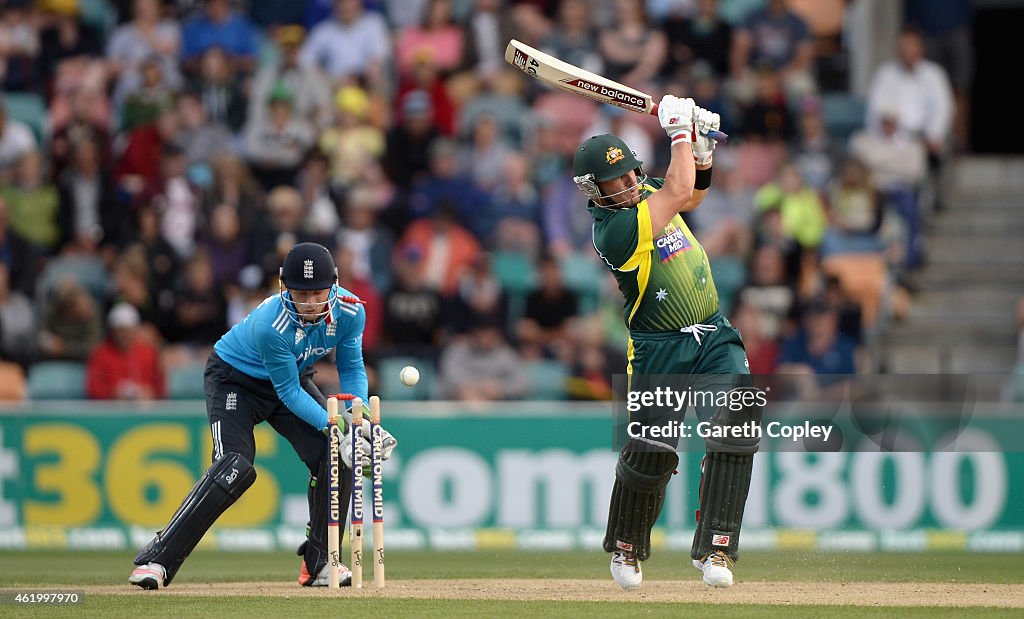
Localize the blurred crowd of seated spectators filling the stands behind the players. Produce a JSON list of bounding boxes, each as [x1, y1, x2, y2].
[[0, 0, 970, 401]]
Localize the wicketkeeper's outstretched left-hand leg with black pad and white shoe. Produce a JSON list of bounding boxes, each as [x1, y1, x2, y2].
[[129, 452, 256, 589]]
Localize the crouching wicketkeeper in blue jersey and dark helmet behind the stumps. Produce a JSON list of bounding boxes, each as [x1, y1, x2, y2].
[[128, 243, 397, 589]]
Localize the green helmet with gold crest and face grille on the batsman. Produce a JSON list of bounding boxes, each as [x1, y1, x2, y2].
[[572, 133, 647, 208]]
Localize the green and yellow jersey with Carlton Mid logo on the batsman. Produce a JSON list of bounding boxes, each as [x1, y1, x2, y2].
[[588, 178, 718, 331]]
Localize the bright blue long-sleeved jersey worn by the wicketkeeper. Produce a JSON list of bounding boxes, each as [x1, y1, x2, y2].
[[213, 285, 368, 429]]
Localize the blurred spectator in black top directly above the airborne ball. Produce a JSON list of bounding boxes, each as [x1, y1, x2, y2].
[[381, 247, 443, 357]]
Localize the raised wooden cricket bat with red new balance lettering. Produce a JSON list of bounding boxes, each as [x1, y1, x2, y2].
[[505, 39, 729, 141]]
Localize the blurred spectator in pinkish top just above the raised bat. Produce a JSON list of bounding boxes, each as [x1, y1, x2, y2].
[[597, 0, 669, 88]]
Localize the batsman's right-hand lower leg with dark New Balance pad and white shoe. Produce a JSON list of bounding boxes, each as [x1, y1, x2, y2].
[[690, 387, 763, 586]]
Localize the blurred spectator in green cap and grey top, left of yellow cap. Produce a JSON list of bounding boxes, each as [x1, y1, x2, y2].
[[245, 83, 315, 190]]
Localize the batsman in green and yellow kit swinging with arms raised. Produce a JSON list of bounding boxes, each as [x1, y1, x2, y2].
[[572, 95, 762, 589]]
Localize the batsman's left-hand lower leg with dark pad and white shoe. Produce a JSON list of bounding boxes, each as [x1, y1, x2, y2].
[[604, 439, 679, 589]]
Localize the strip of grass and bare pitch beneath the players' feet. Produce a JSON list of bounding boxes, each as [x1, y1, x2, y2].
[[0, 550, 1024, 619]]
